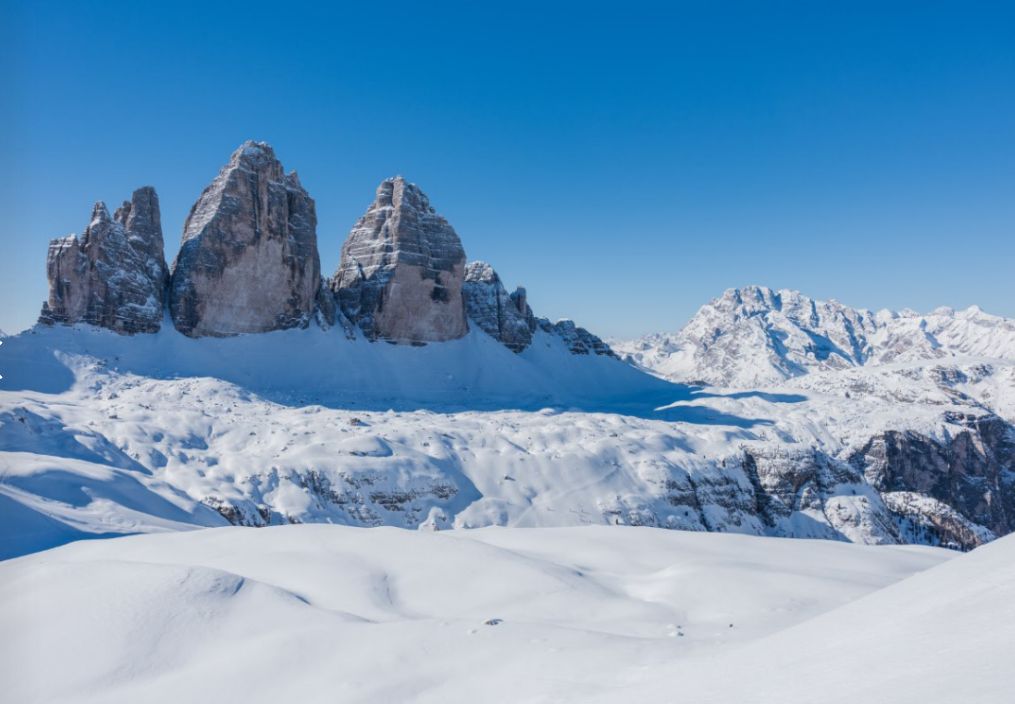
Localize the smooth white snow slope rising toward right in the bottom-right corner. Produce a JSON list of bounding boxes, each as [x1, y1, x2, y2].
[[609, 537, 1015, 704]]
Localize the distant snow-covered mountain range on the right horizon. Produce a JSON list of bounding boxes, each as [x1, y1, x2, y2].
[[611, 286, 1015, 389]]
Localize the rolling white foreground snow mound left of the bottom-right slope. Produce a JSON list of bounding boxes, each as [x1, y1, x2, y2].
[[0, 525, 950, 704]]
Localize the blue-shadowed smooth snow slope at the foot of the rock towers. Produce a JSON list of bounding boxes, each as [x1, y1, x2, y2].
[[0, 322, 672, 410]]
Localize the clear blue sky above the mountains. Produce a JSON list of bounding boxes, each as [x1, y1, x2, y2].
[[0, 0, 1015, 336]]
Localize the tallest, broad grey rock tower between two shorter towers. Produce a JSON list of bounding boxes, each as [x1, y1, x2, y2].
[[170, 141, 321, 337]]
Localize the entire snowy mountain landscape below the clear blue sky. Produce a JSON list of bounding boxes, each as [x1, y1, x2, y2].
[[0, 147, 1015, 704]]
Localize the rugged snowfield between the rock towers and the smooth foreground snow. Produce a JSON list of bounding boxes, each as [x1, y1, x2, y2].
[[0, 318, 1015, 558]]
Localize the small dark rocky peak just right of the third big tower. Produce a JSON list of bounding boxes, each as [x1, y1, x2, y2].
[[462, 262, 536, 352]]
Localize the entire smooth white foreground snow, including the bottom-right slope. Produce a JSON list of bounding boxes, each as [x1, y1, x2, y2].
[[0, 525, 982, 704]]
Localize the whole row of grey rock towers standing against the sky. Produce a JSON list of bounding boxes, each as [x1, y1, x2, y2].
[[40, 141, 613, 355]]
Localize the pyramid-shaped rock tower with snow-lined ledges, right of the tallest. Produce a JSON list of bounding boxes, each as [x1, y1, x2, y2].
[[331, 177, 469, 343]]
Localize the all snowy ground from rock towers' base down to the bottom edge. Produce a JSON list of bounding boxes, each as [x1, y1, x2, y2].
[[0, 320, 1015, 704]]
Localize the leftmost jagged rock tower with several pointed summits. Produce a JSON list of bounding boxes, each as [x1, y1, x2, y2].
[[39, 187, 167, 335]]
